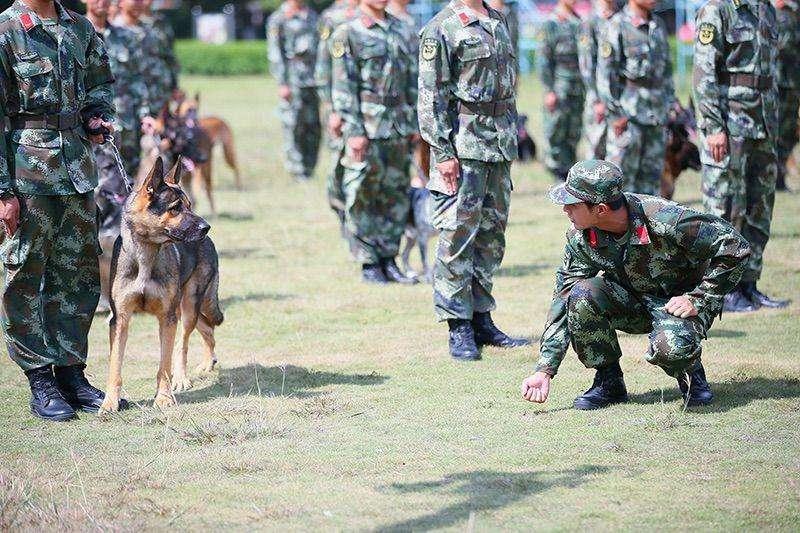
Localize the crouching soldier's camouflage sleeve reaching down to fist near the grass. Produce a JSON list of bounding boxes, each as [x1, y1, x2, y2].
[[535, 239, 599, 376]]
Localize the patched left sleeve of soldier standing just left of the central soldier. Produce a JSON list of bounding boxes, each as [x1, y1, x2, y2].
[[331, 27, 367, 139]]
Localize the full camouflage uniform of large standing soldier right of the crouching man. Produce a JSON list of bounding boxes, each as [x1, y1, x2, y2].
[[693, 0, 778, 283]]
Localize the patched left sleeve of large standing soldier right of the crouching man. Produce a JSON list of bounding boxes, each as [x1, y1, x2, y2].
[[692, 2, 725, 136]]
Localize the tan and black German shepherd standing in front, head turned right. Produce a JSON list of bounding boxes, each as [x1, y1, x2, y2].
[[101, 158, 223, 412]]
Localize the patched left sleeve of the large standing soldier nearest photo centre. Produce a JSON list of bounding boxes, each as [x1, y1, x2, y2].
[[417, 28, 456, 163]]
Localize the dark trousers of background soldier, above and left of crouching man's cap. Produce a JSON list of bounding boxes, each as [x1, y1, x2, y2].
[[544, 94, 584, 176]]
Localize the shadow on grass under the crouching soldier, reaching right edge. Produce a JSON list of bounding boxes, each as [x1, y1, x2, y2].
[[630, 377, 800, 413]]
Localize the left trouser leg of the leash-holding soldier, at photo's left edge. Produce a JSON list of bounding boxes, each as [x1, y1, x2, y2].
[[0, 196, 64, 370]]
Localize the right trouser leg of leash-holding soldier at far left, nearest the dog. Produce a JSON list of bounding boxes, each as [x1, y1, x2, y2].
[[42, 193, 100, 366]]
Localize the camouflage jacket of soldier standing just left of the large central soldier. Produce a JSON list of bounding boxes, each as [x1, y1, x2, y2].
[[330, 12, 417, 139]]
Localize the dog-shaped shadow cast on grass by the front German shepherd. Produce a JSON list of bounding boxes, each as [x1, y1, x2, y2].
[[178, 365, 389, 403]]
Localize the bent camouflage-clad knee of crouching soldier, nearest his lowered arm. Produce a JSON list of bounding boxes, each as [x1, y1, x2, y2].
[[567, 276, 652, 368]]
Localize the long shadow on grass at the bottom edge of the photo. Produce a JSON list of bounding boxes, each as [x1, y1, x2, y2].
[[377, 465, 608, 532]]
